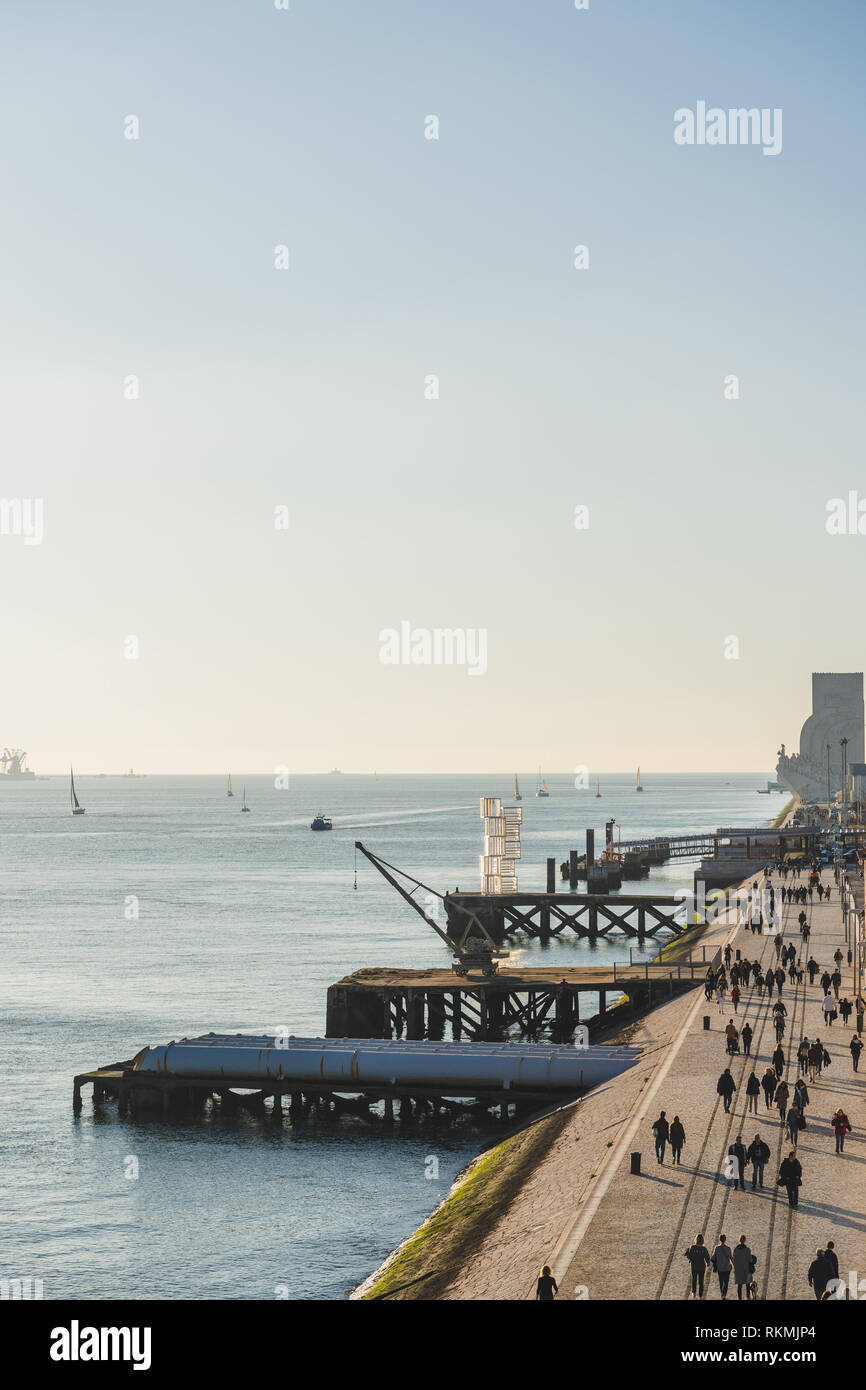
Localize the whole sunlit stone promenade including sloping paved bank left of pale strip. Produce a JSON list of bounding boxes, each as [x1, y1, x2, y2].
[[443, 870, 866, 1300]]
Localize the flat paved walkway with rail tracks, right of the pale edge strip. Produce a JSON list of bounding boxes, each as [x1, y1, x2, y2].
[[556, 873, 866, 1300]]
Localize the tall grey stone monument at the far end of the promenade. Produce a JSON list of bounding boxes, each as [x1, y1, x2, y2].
[[776, 671, 866, 802]]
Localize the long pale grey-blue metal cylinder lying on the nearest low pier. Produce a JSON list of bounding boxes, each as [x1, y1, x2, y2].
[[135, 1033, 639, 1091]]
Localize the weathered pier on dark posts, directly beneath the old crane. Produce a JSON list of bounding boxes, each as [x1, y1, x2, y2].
[[325, 960, 706, 1043]]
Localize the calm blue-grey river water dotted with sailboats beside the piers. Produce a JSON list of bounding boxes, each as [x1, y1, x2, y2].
[[0, 774, 784, 1298]]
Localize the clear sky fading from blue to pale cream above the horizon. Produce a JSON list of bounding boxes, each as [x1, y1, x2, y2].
[[0, 0, 866, 773]]
